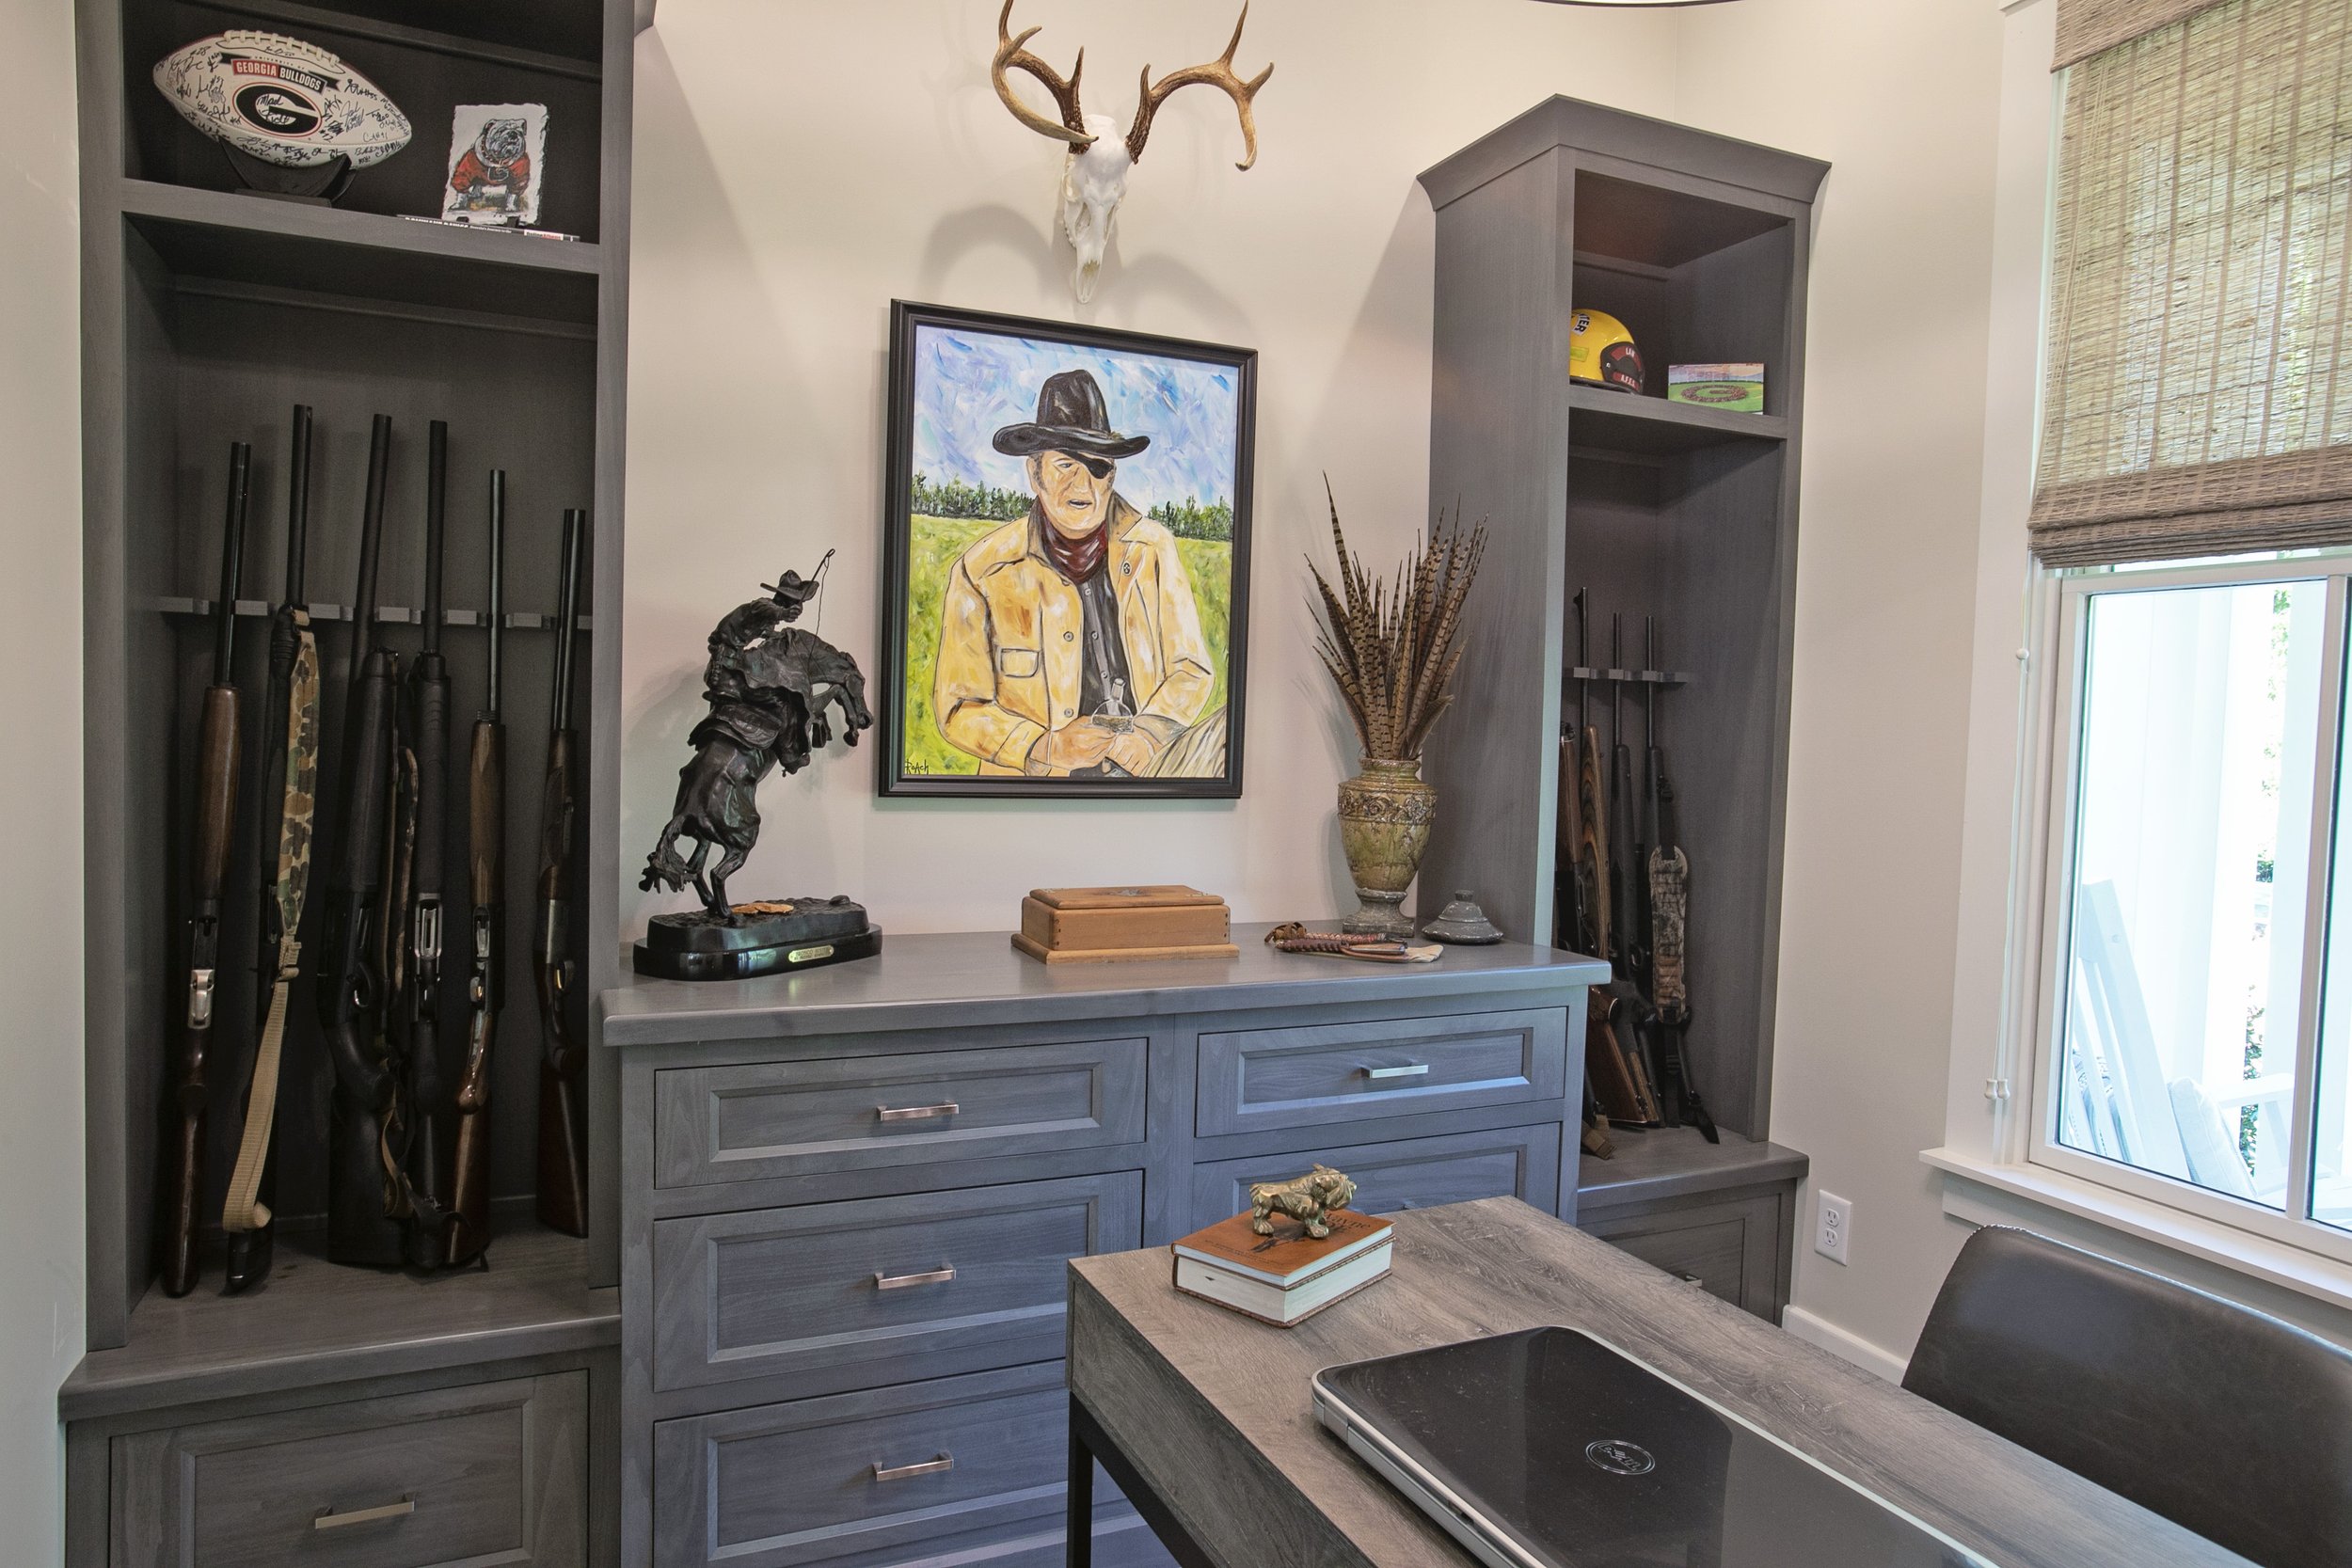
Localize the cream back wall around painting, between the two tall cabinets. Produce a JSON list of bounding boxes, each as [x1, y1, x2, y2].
[[621, 0, 1675, 933]]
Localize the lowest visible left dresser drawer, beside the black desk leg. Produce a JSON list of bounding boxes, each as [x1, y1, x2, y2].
[[654, 1361, 1068, 1568]]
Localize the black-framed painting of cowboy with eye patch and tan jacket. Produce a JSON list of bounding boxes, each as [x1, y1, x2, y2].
[[878, 301, 1259, 800]]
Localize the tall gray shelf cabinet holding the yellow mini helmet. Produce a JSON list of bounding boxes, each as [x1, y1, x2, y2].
[[1421, 99, 1828, 1166]]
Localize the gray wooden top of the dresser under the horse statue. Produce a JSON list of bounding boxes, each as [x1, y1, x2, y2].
[[597, 927, 1609, 1046]]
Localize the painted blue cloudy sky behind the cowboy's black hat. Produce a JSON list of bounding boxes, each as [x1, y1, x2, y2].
[[915, 326, 1240, 513]]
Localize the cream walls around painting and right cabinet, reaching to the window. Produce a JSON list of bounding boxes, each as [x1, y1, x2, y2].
[[621, 0, 2030, 1356]]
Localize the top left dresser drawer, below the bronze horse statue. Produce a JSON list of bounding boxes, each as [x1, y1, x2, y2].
[[654, 1039, 1146, 1187]]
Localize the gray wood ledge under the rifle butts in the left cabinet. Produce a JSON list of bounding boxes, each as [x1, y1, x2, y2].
[[56, 1225, 621, 1422]]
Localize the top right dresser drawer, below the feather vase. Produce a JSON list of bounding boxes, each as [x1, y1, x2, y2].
[[1195, 1008, 1569, 1138]]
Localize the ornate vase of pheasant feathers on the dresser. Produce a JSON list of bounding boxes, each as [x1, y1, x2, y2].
[[1308, 480, 1486, 938]]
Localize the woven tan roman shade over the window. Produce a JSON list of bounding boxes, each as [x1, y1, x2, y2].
[[2032, 0, 2352, 566]]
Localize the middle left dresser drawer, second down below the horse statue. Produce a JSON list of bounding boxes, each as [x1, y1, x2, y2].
[[654, 1171, 1143, 1389]]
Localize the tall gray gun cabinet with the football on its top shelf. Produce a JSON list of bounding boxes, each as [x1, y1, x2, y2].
[[59, 0, 640, 1563]]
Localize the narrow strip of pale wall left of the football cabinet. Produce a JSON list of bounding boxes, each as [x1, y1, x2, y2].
[[0, 0, 83, 1563]]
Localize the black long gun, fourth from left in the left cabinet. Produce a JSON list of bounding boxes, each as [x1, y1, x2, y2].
[[400, 419, 452, 1270]]
